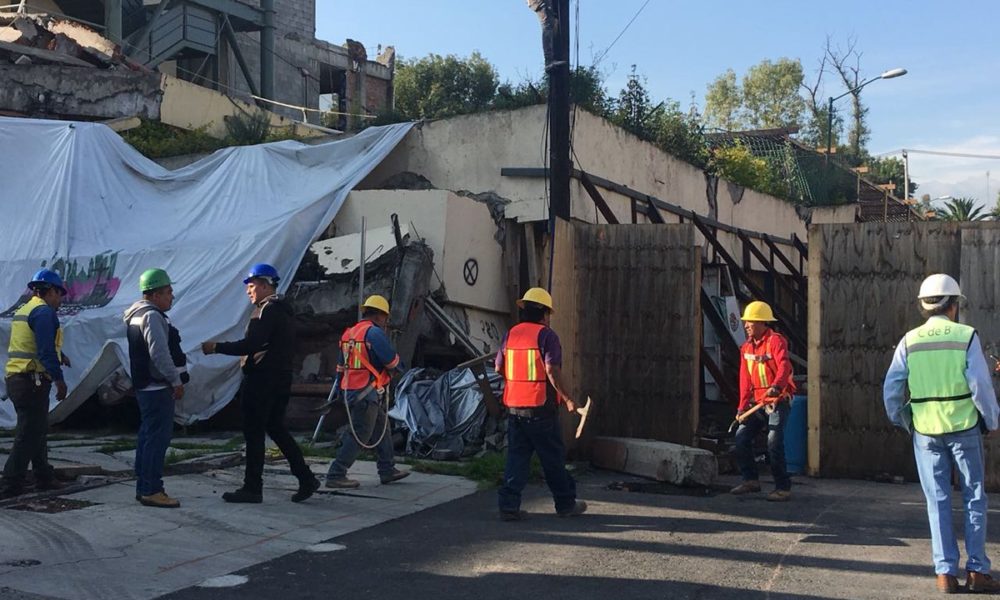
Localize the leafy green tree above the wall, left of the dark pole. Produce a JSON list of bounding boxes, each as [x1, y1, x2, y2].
[[394, 52, 498, 120]]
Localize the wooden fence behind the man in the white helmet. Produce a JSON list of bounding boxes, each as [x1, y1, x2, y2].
[[808, 223, 1000, 489]]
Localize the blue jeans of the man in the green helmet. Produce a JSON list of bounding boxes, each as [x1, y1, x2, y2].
[[135, 388, 174, 496]]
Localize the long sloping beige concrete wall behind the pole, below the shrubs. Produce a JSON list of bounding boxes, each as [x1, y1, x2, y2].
[[359, 106, 854, 268]]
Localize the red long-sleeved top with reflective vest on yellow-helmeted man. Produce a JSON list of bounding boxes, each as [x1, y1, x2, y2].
[[737, 329, 795, 412]]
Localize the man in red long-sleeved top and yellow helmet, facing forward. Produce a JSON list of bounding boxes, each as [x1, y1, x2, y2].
[[730, 301, 795, 502]]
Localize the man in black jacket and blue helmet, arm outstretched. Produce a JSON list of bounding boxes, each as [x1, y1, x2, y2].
[[201, 263, 320, 503]]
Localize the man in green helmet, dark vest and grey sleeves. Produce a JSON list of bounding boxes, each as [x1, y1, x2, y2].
[[124, 269, 187, 508]]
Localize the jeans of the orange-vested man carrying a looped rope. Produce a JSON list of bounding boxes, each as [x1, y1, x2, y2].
[[326, 391, 396, 479]]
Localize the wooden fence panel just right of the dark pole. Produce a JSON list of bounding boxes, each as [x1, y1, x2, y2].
[[552, 222, 702, 444]]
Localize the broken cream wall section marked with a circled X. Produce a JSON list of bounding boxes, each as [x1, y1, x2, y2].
[[333, 190, 510, 314]]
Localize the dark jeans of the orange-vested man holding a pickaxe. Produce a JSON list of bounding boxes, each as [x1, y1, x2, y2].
[[498, 414, 576, 513]]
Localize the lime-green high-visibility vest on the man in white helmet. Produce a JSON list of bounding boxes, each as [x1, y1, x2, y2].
[[904, 317, 979, 435]]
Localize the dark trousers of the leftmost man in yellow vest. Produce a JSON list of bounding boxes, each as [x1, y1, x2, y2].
[[3, 374, 54, 489]]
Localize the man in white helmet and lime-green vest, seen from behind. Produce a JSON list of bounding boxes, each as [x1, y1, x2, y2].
[[882, 273, 1000, 594]]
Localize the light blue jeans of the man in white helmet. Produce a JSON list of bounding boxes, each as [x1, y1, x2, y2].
[[913, 427, 990, 575]]
